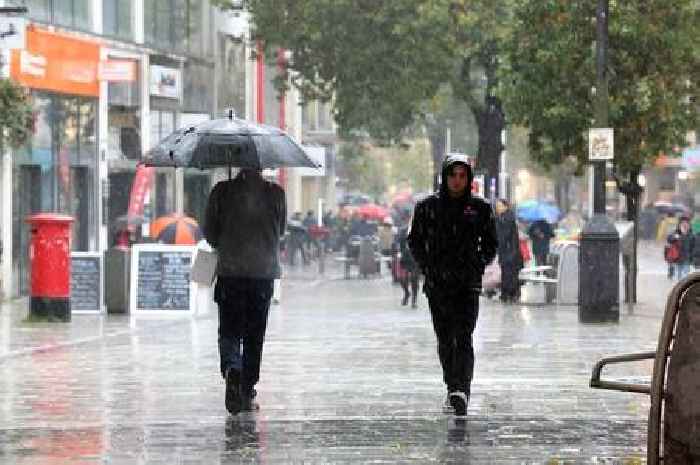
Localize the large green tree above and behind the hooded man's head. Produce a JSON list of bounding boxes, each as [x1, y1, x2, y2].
[[215, 0, 511, 191]]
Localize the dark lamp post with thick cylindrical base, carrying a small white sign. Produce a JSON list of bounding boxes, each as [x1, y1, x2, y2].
[[579, 0, 620, 323]]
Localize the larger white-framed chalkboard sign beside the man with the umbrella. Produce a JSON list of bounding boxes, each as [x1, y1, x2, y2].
[[130, 244, 196, 314]]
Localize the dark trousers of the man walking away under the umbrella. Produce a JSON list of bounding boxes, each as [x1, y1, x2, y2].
[[214, 276, 273, 393]]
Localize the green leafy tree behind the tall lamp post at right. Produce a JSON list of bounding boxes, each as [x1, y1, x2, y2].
[[499, 0, 700, 300]]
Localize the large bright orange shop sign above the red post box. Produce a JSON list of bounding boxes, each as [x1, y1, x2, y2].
[[10, 27, 100, 97]]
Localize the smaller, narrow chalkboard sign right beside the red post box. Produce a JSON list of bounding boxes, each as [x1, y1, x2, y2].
[[70, 252, 102, 313]]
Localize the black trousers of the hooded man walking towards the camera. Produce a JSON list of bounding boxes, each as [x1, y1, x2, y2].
[[428, 292, 479, 395]]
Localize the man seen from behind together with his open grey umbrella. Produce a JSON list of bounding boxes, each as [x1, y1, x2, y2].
[[144, 111, 317, 414]]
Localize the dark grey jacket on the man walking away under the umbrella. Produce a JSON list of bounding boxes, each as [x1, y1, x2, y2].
[[204, 170, 287, 279]]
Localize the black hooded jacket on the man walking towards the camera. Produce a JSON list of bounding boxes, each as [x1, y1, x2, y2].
[[408, 155, 498, 296]]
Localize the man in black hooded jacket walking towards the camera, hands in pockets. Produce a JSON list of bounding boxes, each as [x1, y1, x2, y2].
[[408, 155, 498, 416]]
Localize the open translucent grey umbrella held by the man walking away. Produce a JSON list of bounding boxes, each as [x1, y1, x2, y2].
[[144, 114, 318, 169]]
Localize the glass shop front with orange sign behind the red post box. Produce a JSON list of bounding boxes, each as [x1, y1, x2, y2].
[[10, 27, 100, 294]]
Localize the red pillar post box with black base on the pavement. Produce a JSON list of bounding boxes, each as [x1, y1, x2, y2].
[[27, 213, 73, 321]]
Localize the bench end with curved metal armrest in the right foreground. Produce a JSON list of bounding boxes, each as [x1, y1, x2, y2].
[[590, 273, 700, 465]]
